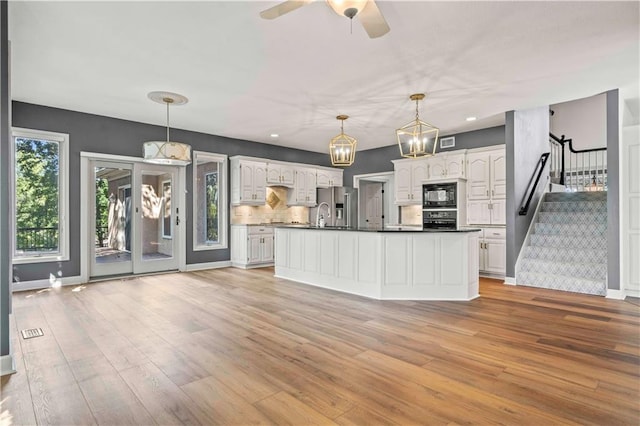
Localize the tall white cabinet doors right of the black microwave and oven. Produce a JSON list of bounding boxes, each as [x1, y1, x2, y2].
[[466, 148, 506, 225]]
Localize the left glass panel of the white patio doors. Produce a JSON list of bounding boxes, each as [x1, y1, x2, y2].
[[90, 161, 133, 277]]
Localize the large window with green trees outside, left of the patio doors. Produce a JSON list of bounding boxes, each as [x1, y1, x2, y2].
[[12, 129, 69, 263]]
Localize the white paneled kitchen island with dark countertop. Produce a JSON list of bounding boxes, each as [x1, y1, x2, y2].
[[275, 227, 479, 300]]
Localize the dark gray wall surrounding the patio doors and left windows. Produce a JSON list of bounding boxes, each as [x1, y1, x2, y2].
[[11, 101, 331, 281]]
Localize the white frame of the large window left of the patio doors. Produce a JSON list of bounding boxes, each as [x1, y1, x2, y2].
[[10, 127, 69, 264]]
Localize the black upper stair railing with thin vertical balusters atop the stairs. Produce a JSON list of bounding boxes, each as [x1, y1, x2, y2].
[[549, 133, 607, 192]]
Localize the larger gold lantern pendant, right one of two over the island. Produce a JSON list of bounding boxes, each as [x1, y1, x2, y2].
[[396, 93, 440, 158]]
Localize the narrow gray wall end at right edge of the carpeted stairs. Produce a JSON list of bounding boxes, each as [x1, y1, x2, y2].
[[606, 89, 620, 290]]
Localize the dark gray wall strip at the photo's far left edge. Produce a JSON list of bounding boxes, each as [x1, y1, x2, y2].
[[0, 1, 11, 362]]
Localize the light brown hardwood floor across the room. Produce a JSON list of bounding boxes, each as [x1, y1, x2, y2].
[[0, 268, 640, 425]]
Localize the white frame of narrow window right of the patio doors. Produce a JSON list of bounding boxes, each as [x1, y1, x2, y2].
[[191, 151, 229, 251]]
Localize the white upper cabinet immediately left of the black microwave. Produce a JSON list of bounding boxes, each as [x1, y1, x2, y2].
[[393, 159, 428, 206]]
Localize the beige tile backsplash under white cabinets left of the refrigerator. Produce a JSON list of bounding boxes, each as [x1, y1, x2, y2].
[[231, 187, 309, 224]]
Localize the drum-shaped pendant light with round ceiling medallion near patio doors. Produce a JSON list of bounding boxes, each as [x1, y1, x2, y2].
[[142, 92, 191, 166]]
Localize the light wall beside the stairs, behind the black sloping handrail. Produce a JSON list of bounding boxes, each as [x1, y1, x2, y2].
[[505, 106, 549, 278]]
